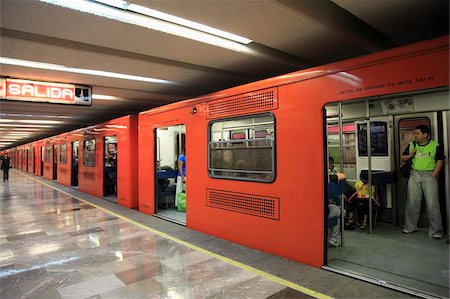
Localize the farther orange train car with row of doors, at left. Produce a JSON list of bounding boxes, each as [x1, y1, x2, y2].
[[17, 115, 138, 209]]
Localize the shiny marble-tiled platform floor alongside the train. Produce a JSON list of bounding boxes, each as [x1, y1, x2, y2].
[[0, 170, 411, 299]]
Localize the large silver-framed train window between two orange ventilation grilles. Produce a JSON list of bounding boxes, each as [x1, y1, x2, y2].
[[208, 114, 275, 182]]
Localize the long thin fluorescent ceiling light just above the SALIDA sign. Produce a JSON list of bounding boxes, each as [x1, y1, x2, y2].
[[0, 57, 176, 84]]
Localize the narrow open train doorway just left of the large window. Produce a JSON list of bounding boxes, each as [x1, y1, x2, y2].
[[155, 125, 188, 224]]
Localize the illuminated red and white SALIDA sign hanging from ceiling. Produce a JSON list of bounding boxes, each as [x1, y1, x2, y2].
[[0, 78, 92, 105]]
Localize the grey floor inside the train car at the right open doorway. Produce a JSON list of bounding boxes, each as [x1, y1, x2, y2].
[[329, 223, 450, 298]]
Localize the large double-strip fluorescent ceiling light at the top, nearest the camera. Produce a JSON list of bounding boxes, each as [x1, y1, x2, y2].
[[40, 0, 257, 55]]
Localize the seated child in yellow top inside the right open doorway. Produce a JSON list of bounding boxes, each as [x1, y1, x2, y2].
[[348, 170, 380, 229]]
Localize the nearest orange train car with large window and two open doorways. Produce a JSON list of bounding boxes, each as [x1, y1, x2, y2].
[[138, 37, 449, 267]]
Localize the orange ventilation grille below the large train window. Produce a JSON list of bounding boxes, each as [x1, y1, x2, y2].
[[206, 189, 280, 220]]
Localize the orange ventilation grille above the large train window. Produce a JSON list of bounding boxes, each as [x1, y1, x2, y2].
[[208, 88, 278, 118]]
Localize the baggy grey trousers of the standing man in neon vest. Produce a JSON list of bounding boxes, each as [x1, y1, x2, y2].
[[405, 170, 442, 236]]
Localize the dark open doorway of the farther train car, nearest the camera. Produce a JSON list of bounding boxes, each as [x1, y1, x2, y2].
[[103, 135, 118, 203]]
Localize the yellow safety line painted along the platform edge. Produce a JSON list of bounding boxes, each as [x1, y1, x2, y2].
[[19, 173, 333, 299]]
